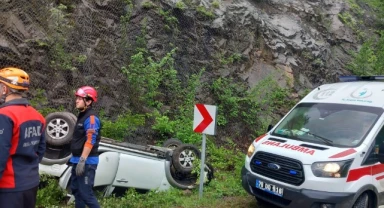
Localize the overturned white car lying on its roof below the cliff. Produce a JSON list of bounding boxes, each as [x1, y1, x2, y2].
[[39, 112, 213, 196]]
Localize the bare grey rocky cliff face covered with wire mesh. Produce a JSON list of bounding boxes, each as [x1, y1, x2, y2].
[[0, 0, 376, 141]]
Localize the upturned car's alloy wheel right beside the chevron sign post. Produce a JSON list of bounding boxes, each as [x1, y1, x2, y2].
[[172, 144, 201, 173]]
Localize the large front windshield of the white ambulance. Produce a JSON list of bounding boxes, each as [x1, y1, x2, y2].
[[272, 103, 383, 147]]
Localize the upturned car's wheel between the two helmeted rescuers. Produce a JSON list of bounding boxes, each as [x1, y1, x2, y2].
[[45, 112, 75, 146]]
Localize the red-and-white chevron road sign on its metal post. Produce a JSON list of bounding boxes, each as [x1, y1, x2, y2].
[[193, 104, 217, 199]]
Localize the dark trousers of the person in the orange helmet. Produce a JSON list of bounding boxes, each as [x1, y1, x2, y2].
[[0, 186, 38, 208]]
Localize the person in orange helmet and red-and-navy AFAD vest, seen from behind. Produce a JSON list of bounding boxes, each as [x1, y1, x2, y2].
[[0, 67, 45, 208]]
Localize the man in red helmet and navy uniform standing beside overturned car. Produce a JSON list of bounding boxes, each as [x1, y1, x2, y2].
[[69, 86, 101, 208]]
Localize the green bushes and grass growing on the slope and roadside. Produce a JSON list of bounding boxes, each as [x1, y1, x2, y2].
[[32, 0, 384, 207]]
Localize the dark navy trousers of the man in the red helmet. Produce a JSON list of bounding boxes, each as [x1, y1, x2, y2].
[[71, 164, 100, 208]]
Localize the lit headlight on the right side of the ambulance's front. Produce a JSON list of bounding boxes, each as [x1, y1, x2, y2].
[[311, 160, 353, 178]]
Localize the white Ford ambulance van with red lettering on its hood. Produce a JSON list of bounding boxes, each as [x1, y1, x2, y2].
[[242, 76, 384, 208]]
